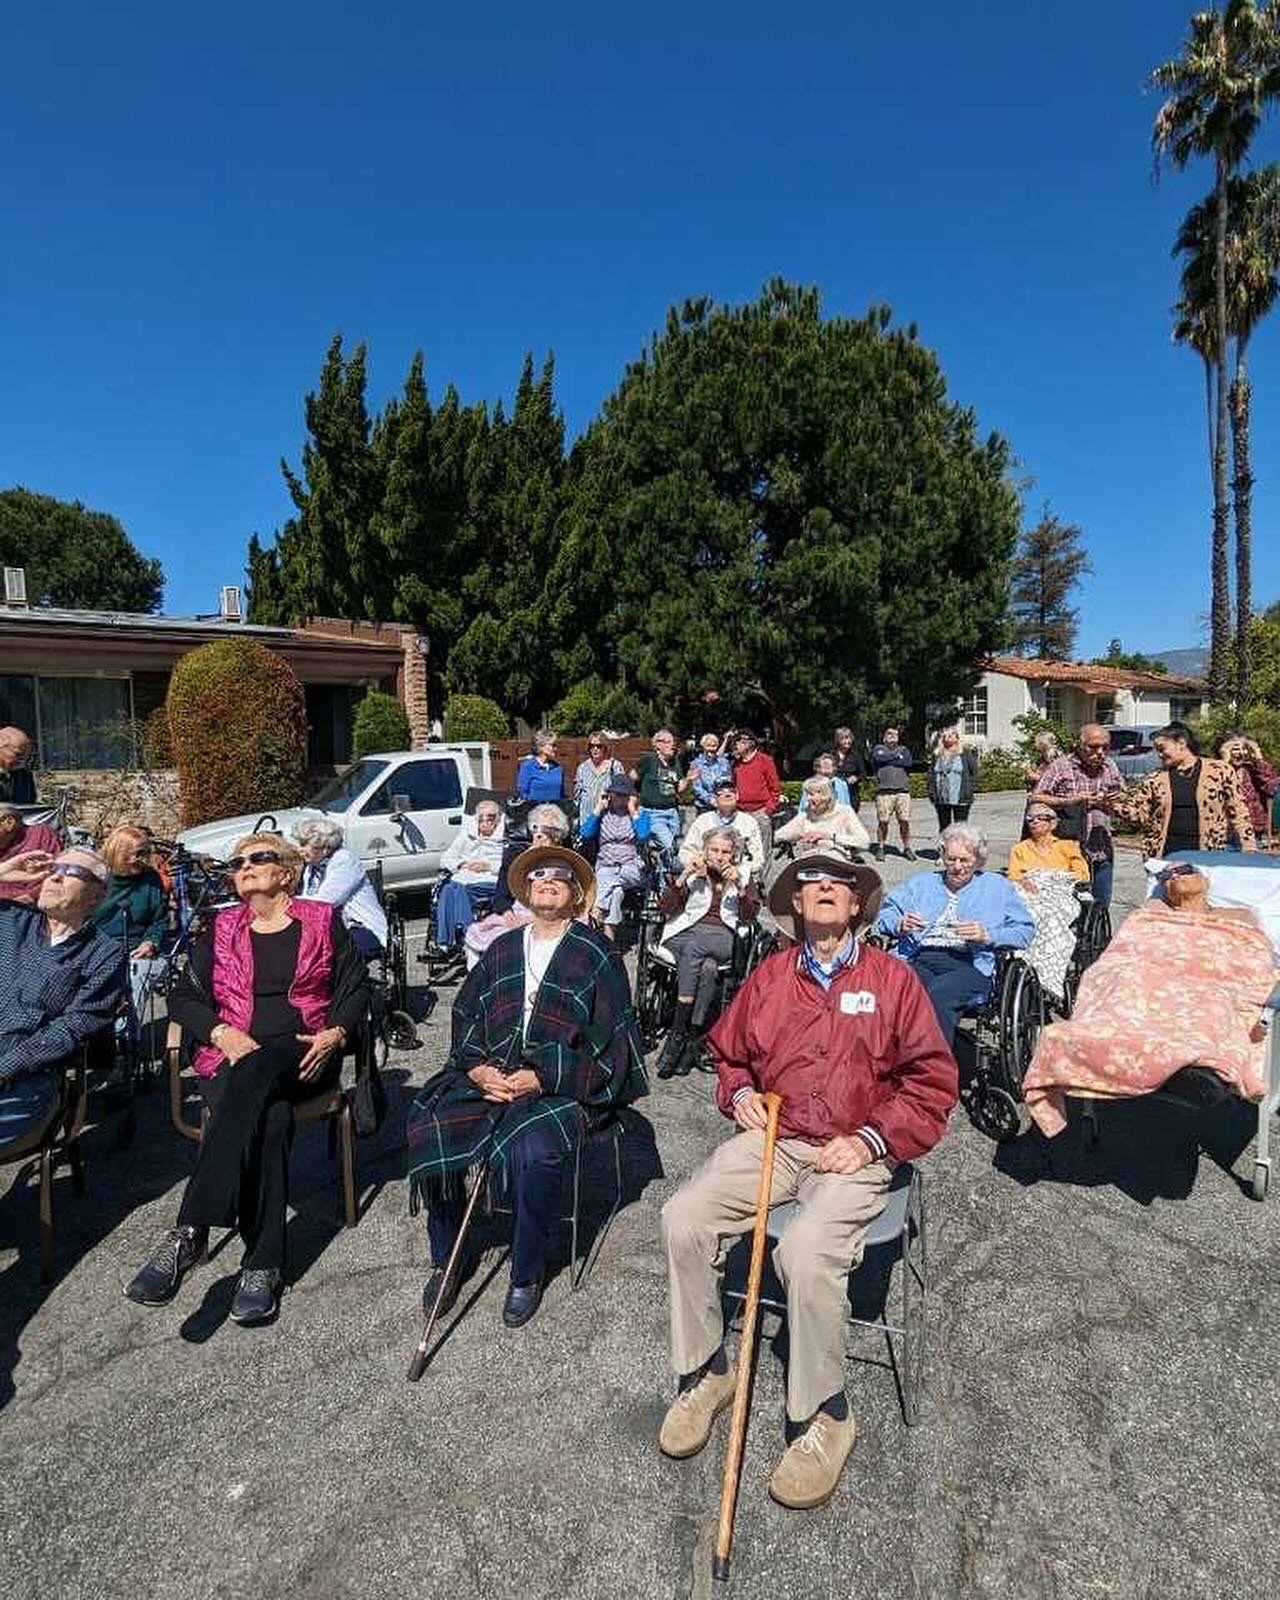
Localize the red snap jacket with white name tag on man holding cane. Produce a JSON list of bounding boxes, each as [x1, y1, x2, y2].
[[707, 944, 958, 1162]]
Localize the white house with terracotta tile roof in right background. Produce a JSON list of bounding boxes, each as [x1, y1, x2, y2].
[[958, 656, 1206, 749]]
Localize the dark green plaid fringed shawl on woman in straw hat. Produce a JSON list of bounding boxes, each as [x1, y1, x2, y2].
[[408, 922, 648, 1198]]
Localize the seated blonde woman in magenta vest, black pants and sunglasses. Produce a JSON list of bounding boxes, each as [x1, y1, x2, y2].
[[125, 834, 370, 1323]]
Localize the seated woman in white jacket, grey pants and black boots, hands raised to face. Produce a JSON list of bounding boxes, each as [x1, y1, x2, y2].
[[658, 827, 760, 1078]]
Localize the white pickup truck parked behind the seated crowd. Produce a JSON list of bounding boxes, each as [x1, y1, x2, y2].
[[178, 744, 490, 890]]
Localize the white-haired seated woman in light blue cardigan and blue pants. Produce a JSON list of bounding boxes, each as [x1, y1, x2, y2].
[[875, 822, 1035, 1045]]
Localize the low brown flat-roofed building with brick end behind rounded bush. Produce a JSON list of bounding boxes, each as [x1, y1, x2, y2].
[[0, 574, 429, 773]]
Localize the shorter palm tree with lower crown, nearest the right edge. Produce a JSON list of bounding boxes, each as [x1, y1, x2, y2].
[[1173, 163, 1280, 707]]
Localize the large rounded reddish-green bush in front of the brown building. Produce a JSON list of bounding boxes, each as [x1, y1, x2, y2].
[[165, 638, 307, 827]]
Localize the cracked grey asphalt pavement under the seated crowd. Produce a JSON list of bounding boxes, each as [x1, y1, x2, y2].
[[0, 797, 1280, 1600]]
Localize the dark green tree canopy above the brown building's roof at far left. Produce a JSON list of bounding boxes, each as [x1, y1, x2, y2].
[[0, 488, 165, 611]]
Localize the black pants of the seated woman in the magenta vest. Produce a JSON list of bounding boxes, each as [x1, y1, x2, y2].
[[178, 1038, 341, 1270]]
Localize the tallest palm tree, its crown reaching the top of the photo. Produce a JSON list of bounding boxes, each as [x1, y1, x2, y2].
[[1149, 0, 1280, 702]]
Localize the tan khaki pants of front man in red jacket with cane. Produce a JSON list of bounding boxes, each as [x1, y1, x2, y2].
[[662, 1133, 893, 1422]]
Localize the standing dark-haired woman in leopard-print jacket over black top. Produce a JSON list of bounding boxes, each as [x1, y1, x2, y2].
[[1110, 722, 1258, 859]]
